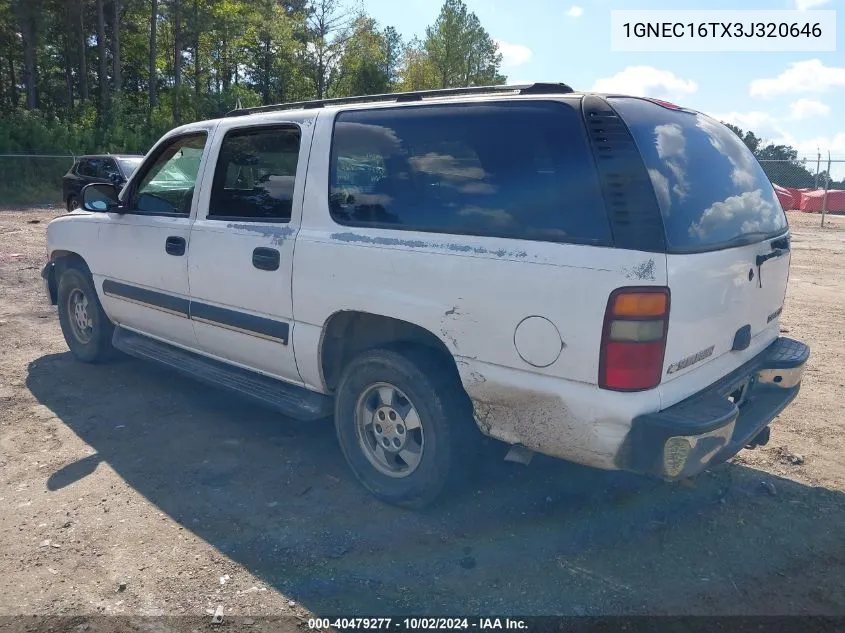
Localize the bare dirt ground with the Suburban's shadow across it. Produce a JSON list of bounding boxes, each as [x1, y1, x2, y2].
[[0, 209, 845, 630]]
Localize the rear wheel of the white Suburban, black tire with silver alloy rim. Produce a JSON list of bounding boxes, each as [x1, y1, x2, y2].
[[335, 348, 480, 508]]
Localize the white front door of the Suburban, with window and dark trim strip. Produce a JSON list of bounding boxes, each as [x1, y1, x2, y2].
[[94, 130, 213, 348]]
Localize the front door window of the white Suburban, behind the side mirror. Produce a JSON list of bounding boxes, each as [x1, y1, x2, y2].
[[132, 133, 207, 216]]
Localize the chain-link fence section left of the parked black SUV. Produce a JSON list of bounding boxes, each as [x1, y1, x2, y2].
[[0, 154, 75, 207]]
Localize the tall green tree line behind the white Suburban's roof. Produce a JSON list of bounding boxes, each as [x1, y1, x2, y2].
[[0, 0, 505, 154]]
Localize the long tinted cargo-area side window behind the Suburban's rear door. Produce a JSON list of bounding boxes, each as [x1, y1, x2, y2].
[[329, 101, 610, 244]]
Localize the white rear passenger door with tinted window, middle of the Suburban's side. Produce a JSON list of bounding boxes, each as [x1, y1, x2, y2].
[[188, 123, 310, 382]]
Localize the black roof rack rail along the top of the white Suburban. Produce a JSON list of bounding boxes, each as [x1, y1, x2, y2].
[[226, 83, 572, 117]]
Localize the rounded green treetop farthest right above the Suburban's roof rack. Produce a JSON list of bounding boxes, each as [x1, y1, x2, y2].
[[423, 0, 505, 88]]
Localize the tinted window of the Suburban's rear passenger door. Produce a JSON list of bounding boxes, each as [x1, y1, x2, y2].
[[208, 127, 299, 222]]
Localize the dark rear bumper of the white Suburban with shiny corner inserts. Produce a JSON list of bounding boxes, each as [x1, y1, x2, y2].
[[617, 337, 810, 480]]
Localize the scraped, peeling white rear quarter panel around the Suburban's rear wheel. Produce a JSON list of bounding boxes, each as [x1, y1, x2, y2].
[[293, 111, 666, 460]]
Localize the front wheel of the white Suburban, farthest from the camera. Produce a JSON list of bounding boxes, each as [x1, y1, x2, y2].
[[57, 267, 114, 363]]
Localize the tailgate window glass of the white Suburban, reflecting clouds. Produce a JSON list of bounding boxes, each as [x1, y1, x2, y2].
[[609, 98, 787, 252]]
